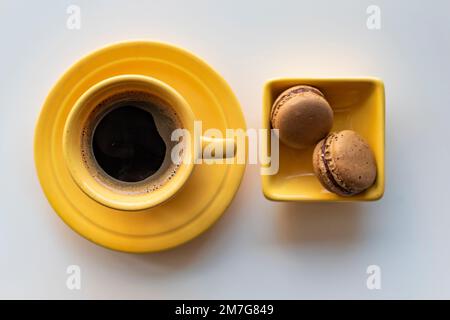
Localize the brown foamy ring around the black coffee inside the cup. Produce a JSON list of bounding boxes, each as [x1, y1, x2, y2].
[[81, 90, 182, 195]]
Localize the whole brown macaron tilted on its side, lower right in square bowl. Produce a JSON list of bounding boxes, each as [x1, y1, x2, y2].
[[313, 130, 377, 196]]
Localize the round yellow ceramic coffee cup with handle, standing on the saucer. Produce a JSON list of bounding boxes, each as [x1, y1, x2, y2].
[[63, 75, 236, 210]]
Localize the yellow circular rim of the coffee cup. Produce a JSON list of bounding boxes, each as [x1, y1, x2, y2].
[[62, 74, 195, 211]]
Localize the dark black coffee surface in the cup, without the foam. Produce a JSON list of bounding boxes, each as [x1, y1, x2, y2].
[[92, 103, 166, 182]]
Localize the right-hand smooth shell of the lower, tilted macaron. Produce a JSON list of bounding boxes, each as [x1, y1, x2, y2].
[[326, 130, 376, 194]]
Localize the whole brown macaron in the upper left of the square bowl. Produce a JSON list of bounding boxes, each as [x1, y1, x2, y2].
[[270, 85, 333, 149]]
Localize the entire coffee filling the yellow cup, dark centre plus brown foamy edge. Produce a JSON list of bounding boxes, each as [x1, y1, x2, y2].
[[81, 90, 181, 195]]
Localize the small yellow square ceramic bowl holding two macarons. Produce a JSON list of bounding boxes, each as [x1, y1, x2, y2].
[[261, 78, 385, 202]]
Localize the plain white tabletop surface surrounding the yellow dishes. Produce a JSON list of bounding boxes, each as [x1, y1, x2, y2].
[[0, 0, 450, 299]]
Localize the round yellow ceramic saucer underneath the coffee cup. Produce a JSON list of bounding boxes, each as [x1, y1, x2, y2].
[[34, 41, 246, 252]]
